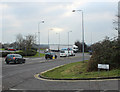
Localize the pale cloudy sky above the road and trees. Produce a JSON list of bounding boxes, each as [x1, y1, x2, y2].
[[0, 0, 118, 44]]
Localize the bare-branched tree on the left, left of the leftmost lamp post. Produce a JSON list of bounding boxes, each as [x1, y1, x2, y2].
[[16, 34, 37, 56]]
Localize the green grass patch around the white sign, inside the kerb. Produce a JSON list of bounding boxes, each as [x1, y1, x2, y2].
[[41, 61, 120, 79]]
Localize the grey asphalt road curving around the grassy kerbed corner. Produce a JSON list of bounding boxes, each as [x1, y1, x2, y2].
[[2, 54, 119, 90]]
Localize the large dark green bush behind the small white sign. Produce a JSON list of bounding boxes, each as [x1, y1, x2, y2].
[[87, 39, 120, 71]]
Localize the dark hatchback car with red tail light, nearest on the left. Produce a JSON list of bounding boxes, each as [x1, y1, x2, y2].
[[5, 54, 25, 64]]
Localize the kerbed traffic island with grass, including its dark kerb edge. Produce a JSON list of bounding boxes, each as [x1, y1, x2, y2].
[[38, 61, 120, 80]]
